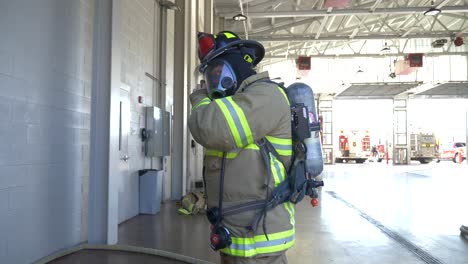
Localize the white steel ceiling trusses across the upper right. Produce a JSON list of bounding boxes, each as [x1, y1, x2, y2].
[[215, 0, 468, 60]]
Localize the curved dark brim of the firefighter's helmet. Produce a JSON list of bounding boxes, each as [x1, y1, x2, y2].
[[199, 40, 265, 71]]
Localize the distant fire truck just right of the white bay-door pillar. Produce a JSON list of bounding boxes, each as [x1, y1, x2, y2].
[[410, 133, 437, 164]]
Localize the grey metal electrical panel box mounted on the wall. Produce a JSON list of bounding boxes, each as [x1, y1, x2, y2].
[[145, 106, 171, 157]]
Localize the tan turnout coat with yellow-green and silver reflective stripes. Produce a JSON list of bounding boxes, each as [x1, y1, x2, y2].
[[189, 72, 294, 257]]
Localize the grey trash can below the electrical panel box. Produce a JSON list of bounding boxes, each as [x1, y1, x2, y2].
[[138, 169, 163, 214]]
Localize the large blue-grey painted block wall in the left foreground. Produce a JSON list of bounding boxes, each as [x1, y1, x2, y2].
[[0, 0, 93, 263]]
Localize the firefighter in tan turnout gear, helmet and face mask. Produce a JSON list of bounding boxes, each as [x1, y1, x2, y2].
[[188, 31, 295, 263]]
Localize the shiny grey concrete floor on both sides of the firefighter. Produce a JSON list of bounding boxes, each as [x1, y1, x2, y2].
[[48, 162, 468, 264]]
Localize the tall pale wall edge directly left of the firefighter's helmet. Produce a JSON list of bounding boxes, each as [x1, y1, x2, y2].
[[171, 0, 213, 200]]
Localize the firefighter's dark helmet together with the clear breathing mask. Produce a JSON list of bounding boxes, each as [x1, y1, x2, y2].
[[198, 31, 265, 99]]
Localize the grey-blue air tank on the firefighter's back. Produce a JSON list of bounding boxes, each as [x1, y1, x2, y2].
[[287, 82, 323, 177]]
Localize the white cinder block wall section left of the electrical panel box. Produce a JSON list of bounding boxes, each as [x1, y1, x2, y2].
[[120, 0, 155, 223]]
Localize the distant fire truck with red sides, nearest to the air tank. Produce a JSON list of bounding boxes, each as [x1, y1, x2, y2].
[[335, 130, 371, 163]]
